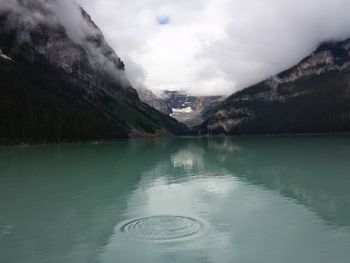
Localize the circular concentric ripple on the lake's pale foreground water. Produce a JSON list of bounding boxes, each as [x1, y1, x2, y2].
[[121, 215, 203, 240]]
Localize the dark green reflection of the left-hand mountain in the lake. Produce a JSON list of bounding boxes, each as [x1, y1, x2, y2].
[[0, 142, 174, 263]]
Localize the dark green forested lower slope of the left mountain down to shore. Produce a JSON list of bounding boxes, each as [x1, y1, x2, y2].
[[0, 59, 186, 142]]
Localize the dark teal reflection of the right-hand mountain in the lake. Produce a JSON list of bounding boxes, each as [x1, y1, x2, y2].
[[207, 136, 350, 226]]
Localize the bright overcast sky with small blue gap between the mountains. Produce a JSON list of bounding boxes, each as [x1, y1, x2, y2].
[[77, 0, 350, 94]]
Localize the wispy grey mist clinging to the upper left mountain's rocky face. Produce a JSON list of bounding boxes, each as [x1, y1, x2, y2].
[[0, 0, 130, 86]]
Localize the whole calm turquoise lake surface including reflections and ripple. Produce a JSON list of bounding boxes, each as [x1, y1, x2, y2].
[[0, 136, 350, 263]]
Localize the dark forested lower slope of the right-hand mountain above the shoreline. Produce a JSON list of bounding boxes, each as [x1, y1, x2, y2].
[[230, 72, 350, 133]]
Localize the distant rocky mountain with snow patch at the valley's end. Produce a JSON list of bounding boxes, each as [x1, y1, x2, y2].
[[139, 89, 224, 127]]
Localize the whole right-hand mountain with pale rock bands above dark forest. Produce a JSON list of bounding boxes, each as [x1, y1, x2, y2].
[[199, 39, 350, 134]]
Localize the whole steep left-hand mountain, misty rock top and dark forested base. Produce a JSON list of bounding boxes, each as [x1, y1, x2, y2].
[[0, 0, 187, 142]]
